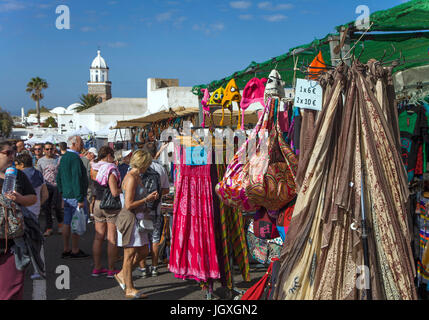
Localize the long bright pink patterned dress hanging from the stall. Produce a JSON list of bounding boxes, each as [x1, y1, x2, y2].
[[169, 165, 220, 282]]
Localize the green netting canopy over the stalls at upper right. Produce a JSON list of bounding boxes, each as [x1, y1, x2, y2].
[[192, 0, 429, 97]]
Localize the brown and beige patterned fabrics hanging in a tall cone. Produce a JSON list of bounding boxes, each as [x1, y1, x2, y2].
[[274, 61, 417, 300]]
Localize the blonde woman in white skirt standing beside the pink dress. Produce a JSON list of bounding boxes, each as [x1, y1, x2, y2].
[[115, 150, 159, 299]]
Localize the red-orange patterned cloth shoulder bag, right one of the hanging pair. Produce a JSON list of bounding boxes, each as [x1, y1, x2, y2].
[[245, 99, 298, 211]]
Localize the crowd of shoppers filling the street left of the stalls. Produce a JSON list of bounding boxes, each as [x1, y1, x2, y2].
[[0, 132, 170, 300]]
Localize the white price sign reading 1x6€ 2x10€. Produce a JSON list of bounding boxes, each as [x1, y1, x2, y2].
[[295, 79, 323, 111]]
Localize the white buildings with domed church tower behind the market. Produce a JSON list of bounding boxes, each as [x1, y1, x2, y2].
[[51, 51, 199, 135]]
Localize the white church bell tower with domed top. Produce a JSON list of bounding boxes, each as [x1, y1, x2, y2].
[[88, 50, 112, 103]]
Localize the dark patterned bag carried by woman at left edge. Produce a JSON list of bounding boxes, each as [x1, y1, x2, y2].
[[0, 194, 24, 250]]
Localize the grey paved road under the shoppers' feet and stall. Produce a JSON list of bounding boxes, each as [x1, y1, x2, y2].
[[24, 217, 264, 300]]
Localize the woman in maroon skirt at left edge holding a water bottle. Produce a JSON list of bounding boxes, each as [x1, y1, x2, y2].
[[0, 141, 37, 300]]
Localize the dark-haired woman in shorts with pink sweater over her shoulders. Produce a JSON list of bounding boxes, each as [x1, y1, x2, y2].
[[91, 146, 121, 278]]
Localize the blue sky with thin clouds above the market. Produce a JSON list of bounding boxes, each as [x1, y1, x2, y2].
[[0, 0, 404, 114]]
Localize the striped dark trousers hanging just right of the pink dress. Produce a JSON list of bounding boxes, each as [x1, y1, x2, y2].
[[217, 164, 250, 289]]
